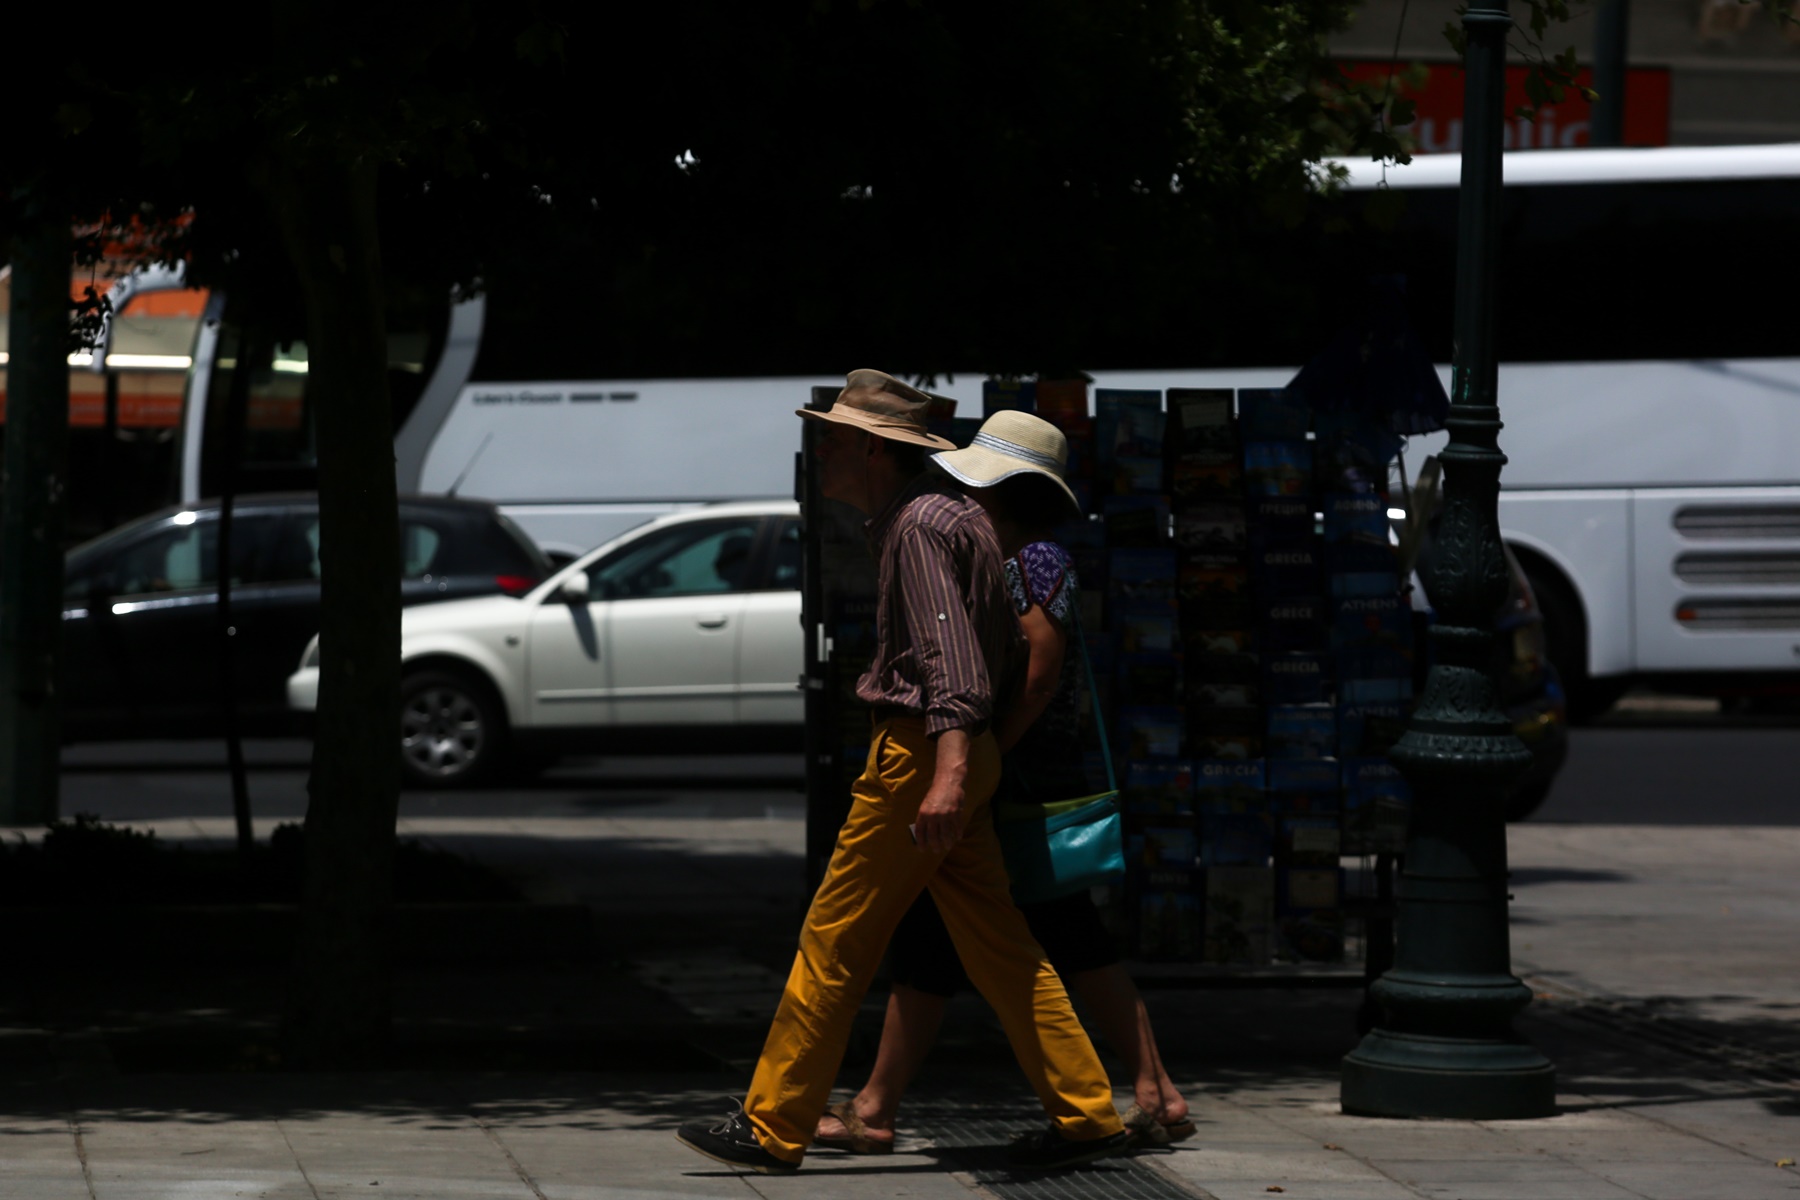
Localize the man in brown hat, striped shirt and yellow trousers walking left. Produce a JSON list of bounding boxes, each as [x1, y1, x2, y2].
[[677, 371, 1129, 1175]]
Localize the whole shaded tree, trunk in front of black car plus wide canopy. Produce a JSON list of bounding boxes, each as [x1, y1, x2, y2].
[[0, 0, 1432, 1063]]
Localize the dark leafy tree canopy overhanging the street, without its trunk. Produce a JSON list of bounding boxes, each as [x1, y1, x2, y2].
[[7, 0, 1418, 374]]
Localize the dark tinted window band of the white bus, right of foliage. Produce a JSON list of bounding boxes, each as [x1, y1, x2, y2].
[[1324, 178, 1800, 363]]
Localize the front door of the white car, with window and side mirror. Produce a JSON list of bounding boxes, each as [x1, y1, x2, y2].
[[529, 516, 761, 727]]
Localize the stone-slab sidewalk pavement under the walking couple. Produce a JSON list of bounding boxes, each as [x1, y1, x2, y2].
[[0, 808, 1800, 1200]]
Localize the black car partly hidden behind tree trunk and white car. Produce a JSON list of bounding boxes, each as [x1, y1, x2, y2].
[[58, 493, 551, 741]]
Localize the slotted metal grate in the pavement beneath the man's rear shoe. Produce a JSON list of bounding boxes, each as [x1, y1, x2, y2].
[[909, 1099, 1211, 1200]]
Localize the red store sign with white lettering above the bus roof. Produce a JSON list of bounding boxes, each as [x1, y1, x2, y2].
[[1339, 61, 1669, 155]]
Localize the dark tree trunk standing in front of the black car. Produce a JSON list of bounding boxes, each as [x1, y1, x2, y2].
[[270, 154, 400, 1067]]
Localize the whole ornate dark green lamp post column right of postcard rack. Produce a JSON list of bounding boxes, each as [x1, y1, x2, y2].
[[1341, 0, 1555, 1119]]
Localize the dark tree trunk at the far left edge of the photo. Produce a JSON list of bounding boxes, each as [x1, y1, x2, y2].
[[0, 200, 74, 824]]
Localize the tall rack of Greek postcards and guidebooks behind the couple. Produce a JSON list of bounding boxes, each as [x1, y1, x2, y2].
[[796, 378, 1415, 986]]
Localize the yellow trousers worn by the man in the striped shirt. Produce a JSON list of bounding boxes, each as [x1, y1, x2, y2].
[[743, 718, 1123, 1162]]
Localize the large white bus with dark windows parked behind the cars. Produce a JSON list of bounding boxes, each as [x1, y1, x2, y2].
[[180, 146, 1800, 714]]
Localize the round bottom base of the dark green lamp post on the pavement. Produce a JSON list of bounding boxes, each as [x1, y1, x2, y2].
[[1339, 1029, 1557, 1121]]
